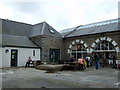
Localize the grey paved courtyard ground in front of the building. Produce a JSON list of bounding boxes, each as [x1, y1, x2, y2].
[[0, 67, 120, 88]]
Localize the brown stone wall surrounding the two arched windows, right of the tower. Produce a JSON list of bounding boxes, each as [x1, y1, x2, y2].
[[62, 32, 120, 60]]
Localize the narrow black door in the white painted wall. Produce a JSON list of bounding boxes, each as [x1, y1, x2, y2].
[[11, 49, 18, 67]]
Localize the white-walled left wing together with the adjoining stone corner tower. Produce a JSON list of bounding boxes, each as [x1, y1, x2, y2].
[[0, 19, 62, 67]]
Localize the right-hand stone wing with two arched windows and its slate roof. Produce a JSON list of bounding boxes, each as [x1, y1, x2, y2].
[[61, 19, 120, 63]]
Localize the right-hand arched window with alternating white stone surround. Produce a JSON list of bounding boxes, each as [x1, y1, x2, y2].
[[90, 37, 119, 63]]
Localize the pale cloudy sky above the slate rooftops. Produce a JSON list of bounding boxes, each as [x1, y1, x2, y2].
[[0, 0, 119, 31]]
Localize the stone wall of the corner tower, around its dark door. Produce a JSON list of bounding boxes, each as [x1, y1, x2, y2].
[[31, 36, 63, 62]]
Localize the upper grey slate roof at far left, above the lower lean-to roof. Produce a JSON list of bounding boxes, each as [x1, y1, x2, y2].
[[2, 19, 33, 37]]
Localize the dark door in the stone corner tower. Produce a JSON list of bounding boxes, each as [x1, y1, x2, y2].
[[49, 49, 60, 63]]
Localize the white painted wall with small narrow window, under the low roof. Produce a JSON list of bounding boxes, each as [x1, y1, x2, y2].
[[2, 47, 40, 67]]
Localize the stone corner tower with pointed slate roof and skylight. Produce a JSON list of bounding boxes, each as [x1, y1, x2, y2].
[[30, 22, 62, 63]]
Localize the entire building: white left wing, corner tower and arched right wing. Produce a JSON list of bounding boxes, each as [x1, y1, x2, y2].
[[0, 19, 120, 67]]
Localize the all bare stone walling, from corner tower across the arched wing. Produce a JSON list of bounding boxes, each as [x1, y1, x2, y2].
[[31, 32, 120, 61]]
